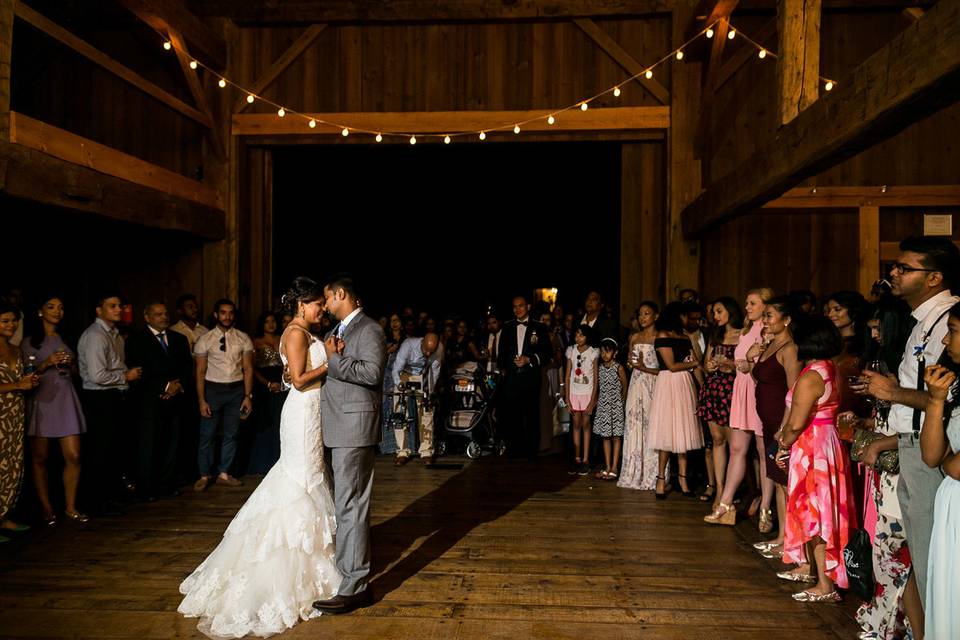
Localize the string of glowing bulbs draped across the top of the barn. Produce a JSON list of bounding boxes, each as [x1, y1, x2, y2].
[[148, 21, 836, 145]]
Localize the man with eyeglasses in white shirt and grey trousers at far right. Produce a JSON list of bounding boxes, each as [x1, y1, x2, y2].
[[861, 236, 960, 602]]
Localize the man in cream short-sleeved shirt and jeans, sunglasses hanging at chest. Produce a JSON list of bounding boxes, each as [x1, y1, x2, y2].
[[193, 298, 253, 491]]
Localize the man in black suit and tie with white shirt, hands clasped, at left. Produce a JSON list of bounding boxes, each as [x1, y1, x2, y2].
[[127, 302, 193, 501]]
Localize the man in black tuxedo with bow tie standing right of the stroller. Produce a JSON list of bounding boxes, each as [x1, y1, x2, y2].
[[497, 296, 553, 460]]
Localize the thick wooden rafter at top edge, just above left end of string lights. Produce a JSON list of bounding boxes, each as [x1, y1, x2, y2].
[[113, 0, 227, 69]]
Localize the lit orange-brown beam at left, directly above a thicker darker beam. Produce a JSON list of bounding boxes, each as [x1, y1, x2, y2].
[[10, 112, 223, 209]]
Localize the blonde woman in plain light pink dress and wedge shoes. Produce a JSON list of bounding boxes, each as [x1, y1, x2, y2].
[[703, 287, 773, 526]]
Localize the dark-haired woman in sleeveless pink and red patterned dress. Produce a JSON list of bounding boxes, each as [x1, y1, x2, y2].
[[777, 317, 856, 602]]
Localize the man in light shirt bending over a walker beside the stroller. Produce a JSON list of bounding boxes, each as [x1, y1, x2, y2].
[[391, 333, 442, 467]]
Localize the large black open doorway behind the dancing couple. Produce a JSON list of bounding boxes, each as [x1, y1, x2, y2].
[[273, 143, 620, 317]]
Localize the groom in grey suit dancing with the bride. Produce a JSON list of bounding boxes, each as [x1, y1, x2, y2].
[[313, 276, 386, 613]]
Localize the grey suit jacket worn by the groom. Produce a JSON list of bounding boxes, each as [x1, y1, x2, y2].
[[321, 311, 387, 447]]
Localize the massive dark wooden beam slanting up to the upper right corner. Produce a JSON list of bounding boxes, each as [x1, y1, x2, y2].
[[683, 2, 960, 234]]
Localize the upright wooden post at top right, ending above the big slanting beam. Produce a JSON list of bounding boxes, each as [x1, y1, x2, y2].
[[777, 0, 821, 124]]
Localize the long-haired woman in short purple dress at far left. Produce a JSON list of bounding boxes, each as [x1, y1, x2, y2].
[[22, 296, 89, 525]]
